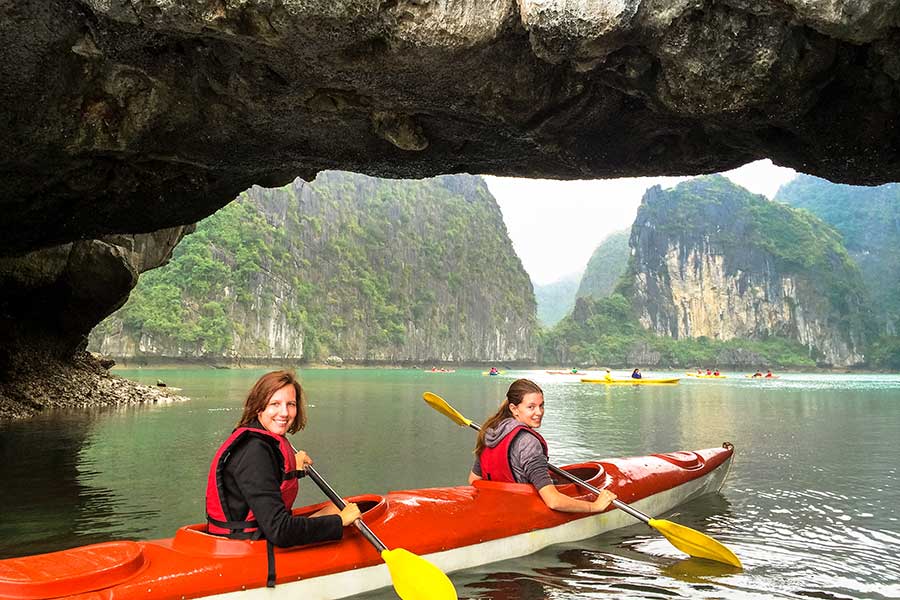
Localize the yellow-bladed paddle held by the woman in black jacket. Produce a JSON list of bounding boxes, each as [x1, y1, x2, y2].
[[305, 465, 457, 600]]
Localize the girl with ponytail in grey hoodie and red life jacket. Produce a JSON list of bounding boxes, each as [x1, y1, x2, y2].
[[469, 379, 616, 513]]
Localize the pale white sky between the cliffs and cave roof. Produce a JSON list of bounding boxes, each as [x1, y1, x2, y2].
[[485, 159, 797, 285]]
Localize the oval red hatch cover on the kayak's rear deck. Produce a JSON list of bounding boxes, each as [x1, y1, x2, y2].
[[0, 541, 147, 600]]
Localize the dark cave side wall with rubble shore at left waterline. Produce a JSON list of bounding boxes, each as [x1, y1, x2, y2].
[[0, 226, 192, 418]]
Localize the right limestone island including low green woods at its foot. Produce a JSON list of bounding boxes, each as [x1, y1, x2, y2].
[[540, 176, 867, 367]]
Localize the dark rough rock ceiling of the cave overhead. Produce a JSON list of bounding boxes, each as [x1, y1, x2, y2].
[[0, 0, 900, 255]]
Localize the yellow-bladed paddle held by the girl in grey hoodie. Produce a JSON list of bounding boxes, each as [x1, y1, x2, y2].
[[422, 392, 743, 568]]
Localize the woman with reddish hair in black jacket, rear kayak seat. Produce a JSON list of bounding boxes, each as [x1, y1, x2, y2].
[[206, 371, 360, 587]]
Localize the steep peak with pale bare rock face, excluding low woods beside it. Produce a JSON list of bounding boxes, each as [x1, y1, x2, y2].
[[628, 176, 866, 366]]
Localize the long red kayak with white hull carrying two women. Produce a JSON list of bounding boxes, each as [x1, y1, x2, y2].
[[0, 444, 733, 600]]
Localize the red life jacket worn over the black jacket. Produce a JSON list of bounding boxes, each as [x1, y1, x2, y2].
[[206, 427, 299, 540]]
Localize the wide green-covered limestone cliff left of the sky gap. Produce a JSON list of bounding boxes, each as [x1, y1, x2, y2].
[[94, 172, 535, 362]]
